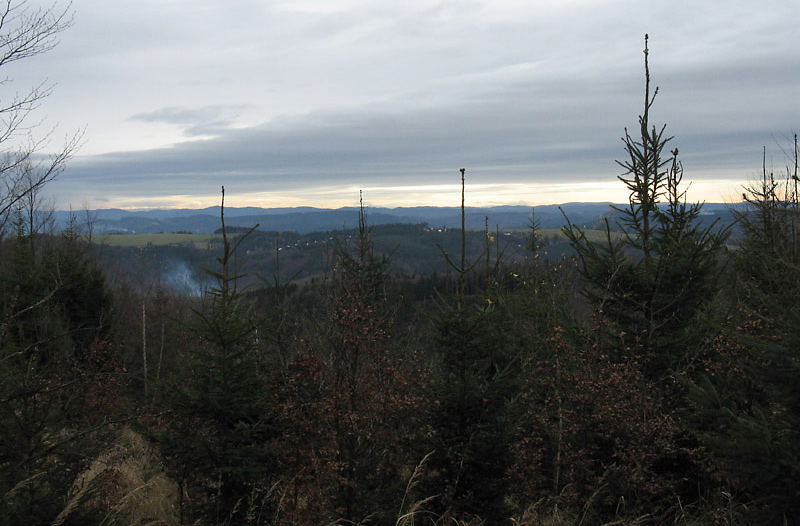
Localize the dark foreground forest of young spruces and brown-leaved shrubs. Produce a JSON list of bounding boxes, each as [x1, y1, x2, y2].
[[0, 8, 800, 526]]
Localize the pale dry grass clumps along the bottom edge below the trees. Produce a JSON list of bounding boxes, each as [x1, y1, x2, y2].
[[53, 428, 747, 526]]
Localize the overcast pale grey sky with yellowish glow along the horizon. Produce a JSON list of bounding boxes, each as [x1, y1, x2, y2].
[[7, 0, 800, 209]]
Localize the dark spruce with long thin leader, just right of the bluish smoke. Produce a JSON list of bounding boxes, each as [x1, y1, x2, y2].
[[160, 187, 274, 524]]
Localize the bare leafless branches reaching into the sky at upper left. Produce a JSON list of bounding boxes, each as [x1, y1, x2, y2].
[[0, 0, 83, 233]]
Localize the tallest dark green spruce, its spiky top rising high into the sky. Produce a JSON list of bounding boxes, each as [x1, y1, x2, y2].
[[564, 36, 728, 379]]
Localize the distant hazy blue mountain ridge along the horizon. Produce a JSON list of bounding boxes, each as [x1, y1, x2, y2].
[[55, 203, 733, 234]]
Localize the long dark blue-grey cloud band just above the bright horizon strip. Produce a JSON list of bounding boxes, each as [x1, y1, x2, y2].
[[54, 71, 758, 206]]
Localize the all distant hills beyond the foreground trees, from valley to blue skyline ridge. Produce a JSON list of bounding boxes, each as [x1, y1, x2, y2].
[[94, 203, 733, 293]]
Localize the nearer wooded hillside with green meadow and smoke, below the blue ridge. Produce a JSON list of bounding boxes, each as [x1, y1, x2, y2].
[[96, 224, 588, 294]]
